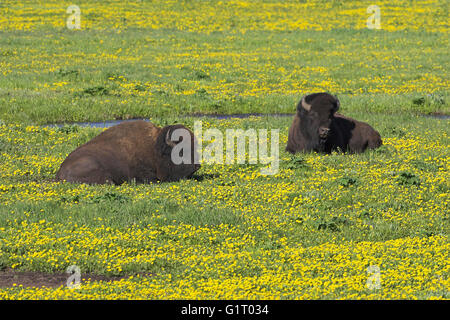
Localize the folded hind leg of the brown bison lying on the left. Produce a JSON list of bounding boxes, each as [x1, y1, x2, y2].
[[56, 157, 115, 184]]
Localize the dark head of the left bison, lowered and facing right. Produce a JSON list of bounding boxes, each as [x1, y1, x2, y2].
[[157, 124, 200, 181]]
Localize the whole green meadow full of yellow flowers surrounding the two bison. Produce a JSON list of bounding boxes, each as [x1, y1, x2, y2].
[[0, 1, 450, 299]]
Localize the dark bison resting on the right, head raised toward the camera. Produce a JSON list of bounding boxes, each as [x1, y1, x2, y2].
[[286, 93, 382, 153]]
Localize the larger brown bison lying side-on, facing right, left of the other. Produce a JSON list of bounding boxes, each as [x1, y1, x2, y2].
[[56, 120, 200, 184]]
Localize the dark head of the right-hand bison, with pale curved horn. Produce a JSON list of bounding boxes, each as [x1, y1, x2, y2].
[[297, 93, 340, 151]]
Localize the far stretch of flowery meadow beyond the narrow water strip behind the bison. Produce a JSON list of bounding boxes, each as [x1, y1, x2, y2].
[[0, 1, 450, 124]]
